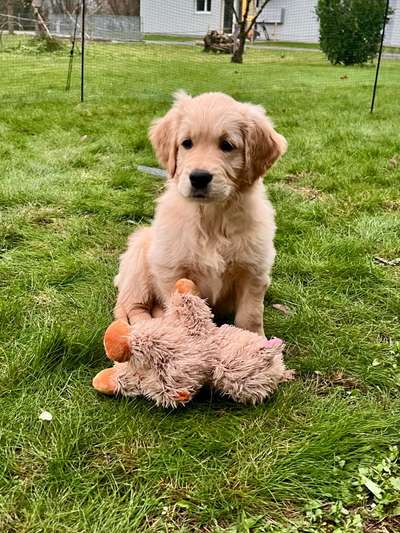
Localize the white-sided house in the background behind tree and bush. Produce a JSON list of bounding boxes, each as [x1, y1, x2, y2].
[[140, 0, 400, 46]]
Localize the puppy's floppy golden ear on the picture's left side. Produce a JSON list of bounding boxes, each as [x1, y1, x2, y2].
[[149, 91, 191, 178]]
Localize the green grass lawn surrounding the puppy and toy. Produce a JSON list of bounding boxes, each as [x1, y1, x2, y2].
[[0, 39, 400, 533]]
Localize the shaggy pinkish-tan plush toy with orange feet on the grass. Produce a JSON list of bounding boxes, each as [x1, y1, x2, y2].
[[93, 279, 293, 407]]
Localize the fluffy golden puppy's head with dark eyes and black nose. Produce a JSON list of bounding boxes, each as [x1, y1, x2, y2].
[[150, 92, 287, 202]]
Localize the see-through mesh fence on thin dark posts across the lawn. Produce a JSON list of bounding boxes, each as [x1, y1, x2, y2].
[[0, 0, 400, 110]]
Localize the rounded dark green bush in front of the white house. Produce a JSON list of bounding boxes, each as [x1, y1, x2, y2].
[[317, 0, 386, 65]]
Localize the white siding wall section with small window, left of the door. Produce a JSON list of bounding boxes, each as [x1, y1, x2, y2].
[[140, 0, 223, 36]]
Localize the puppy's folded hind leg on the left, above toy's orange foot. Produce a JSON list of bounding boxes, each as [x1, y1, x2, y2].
[[114, 228, 154, 324]]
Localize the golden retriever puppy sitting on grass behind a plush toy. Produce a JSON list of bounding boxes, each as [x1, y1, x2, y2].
[[114, 92, 287, 334]]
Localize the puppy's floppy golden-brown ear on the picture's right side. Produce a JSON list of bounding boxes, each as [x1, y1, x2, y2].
[[243, 104, 287, 183]]
